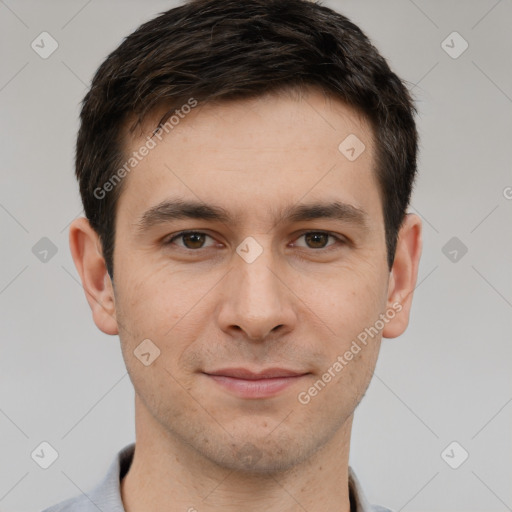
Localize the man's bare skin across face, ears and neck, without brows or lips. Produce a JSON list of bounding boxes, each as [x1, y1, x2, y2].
[[70, 89, 422, 512]]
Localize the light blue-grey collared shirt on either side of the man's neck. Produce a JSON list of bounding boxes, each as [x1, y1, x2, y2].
[[42, 443, 392, 512]]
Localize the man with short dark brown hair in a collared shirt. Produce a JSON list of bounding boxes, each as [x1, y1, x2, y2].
[[43, 0, 421, 512]]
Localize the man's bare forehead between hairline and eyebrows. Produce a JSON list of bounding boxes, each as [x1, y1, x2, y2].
[[118, 90, 380, 230]]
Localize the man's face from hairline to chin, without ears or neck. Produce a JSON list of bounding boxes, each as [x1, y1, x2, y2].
[[99, 91, 400, 472]]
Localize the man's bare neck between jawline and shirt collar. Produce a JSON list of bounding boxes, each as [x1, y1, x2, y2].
[[121, 403, 352, 512]]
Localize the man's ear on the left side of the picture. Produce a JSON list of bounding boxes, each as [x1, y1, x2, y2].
[[69, 217, 119, 335]]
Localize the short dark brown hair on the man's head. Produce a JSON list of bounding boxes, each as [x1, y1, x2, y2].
[[76, 0, 418, 278]]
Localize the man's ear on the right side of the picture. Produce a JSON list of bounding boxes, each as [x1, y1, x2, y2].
[[382, 213, 422, 338]]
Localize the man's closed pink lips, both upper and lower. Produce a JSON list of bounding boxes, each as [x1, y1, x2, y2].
[[205, 368, 308, 399]]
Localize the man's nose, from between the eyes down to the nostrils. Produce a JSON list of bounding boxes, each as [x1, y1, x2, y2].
[[218, 241, 297, 341]]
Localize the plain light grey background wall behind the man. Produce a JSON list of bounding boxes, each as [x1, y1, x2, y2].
[[0, 0, 512, 512]]
